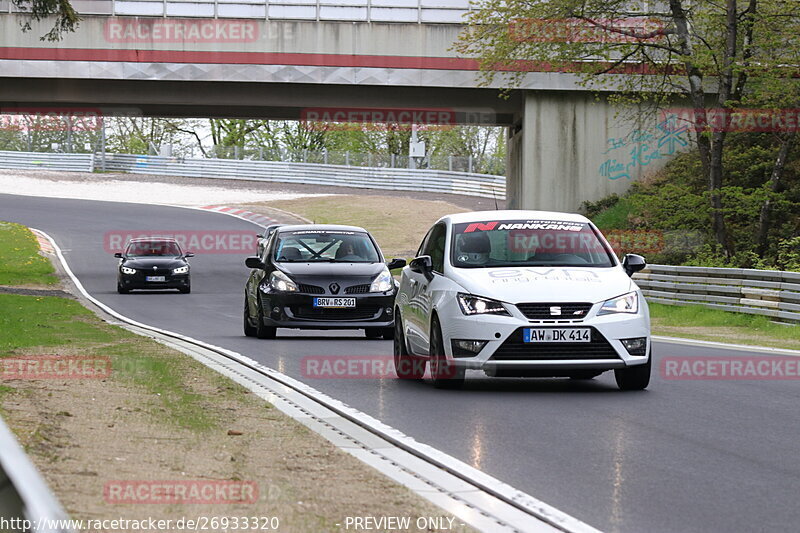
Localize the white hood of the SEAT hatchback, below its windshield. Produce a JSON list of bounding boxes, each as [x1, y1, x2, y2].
[[451, 267, 637, 303]]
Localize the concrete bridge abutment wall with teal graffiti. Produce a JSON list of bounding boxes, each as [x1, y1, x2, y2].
[[508, 91, 689, 211]]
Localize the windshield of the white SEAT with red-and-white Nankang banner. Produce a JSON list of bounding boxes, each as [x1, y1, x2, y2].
[[451, 220, 614, 268]]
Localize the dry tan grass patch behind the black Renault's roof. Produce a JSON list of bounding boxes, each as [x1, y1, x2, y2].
[[265, 195, 465, 258]]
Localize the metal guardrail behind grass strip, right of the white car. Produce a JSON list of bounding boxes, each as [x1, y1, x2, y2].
[[633, 265, 800, 323]]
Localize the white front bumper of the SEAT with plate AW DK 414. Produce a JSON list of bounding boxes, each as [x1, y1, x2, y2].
[[439, 298, 651, 376]]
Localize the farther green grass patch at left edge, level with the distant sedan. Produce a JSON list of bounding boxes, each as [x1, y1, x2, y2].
[[0, 222, 58, 287]]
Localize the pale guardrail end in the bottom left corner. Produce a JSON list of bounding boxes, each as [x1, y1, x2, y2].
[[0, 419, 73, 533]]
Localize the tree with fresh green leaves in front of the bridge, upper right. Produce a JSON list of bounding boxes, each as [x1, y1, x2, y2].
[[456, 0, 800, 255]]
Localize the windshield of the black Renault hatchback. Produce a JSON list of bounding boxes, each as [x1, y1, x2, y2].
[[274, 230, 381, 263]]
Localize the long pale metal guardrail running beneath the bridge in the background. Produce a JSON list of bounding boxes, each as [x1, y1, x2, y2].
[[105, 154, 506, 200]]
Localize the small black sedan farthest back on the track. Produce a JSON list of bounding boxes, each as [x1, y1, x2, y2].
[[114, 237, 194, 294]]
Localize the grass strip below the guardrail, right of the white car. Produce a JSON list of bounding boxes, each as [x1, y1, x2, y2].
[[649, 303, 800, 350]]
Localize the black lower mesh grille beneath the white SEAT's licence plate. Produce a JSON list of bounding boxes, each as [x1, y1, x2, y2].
[[491, 328, 619, 361]]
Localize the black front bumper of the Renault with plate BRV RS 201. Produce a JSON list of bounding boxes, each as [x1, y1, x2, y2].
[[259, 292, 395, 329]]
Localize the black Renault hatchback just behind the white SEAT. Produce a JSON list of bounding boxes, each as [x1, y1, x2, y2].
[[244, 224, 406, 339]]
